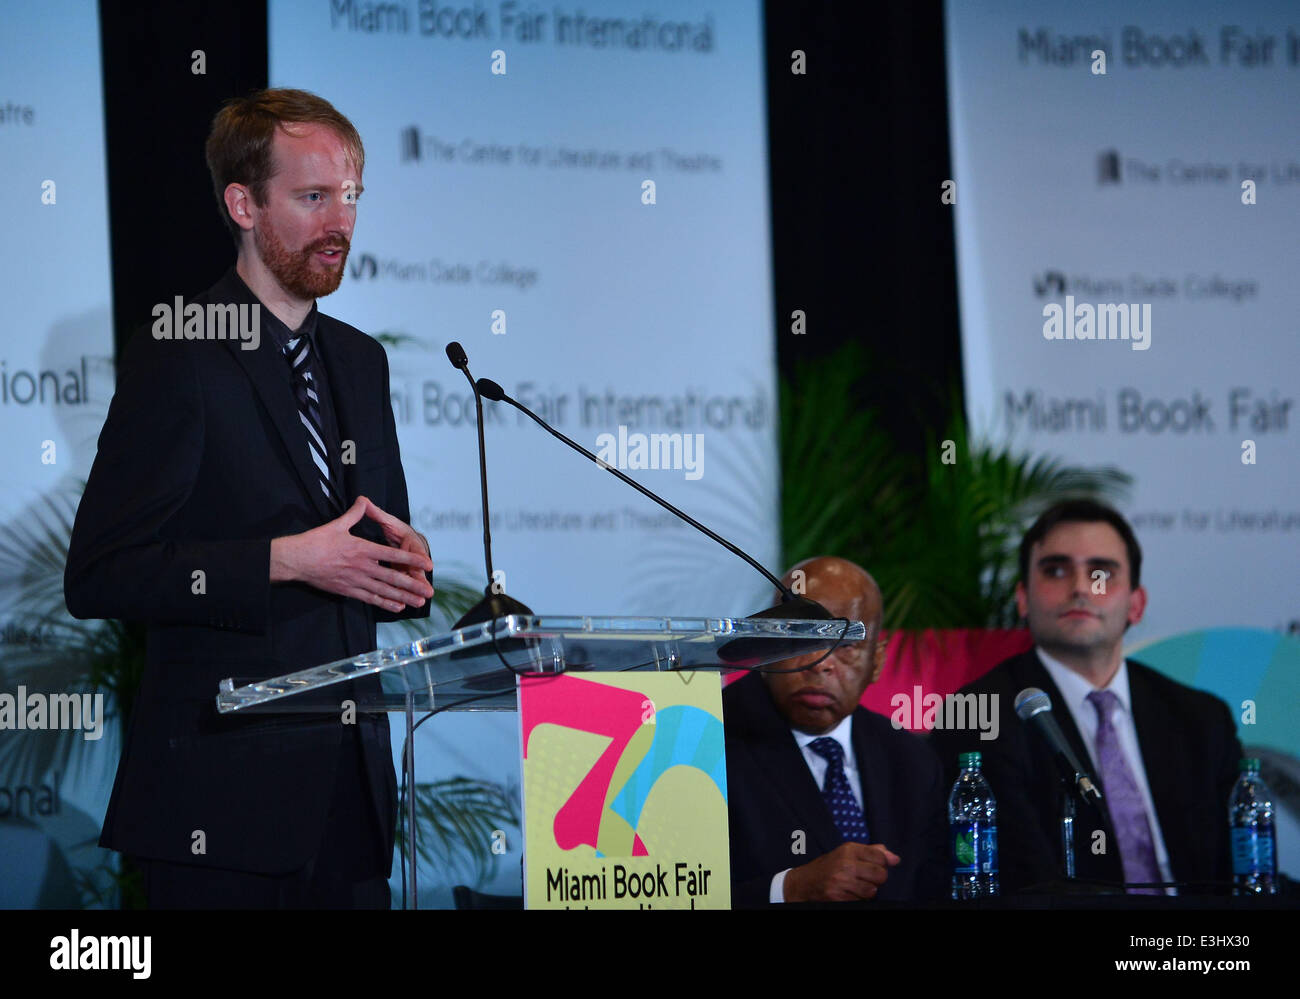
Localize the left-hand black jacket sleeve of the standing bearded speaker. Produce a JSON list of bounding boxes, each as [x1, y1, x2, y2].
[[64, 328, 270, 633]]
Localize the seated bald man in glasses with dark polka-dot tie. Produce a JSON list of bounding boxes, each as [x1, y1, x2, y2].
[[723, 558, 948, 907]]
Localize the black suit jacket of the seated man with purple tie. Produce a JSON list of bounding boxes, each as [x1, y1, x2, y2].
[[933, 650, 1242, 892]]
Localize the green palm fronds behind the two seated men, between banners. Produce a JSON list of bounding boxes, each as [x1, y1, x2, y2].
[[781, 343, 1131, 631]]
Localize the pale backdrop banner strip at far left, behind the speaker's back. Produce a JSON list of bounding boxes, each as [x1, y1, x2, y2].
[[0, 0, 120, 908]]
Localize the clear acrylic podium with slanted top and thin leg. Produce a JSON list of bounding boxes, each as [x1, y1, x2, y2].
[[217, 615, 867, 905]]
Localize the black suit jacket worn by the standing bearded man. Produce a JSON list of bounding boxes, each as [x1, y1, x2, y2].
[[64, 269, 429, 874]]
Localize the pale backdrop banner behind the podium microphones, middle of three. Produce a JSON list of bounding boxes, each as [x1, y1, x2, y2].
[[263, 0, 777, 624]]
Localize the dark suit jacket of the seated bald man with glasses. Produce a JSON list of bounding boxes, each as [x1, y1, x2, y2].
[[723, 675, 949, 907]]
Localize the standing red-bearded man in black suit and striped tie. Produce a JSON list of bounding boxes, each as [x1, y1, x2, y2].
[[64, 90, 433, 908]]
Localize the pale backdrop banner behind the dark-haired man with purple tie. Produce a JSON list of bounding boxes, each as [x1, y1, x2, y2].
[[946, 0, 1300, 640]]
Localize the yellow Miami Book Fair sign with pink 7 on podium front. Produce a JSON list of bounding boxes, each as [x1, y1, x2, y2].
[[519, 673, 731, 909]]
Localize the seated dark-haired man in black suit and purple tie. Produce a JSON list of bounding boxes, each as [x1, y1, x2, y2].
[[933, 500, 1242, 892]]
